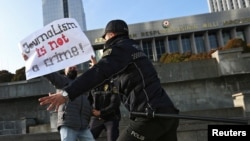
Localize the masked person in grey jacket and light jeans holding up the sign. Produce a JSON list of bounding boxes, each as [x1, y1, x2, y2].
[[44, 66, 95, 141]]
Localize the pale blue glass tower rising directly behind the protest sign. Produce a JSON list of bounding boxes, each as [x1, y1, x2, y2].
[[42, 0, 88, 70]]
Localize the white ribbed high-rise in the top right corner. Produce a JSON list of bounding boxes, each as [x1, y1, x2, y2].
[[207, 0, 250, 12]]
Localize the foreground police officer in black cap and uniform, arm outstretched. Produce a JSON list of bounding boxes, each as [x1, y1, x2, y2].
[[39, 20, 179, 141]]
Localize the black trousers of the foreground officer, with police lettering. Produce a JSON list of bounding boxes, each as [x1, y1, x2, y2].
[[117, 117, 179, 141]]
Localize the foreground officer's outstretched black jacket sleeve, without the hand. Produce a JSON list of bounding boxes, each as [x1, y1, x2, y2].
[[64, 49, 131, 100]]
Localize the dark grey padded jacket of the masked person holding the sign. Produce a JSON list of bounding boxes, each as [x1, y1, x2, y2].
[[45, 73, 92, 130]]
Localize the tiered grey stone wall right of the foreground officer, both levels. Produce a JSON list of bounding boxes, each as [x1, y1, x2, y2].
[[155, 48, 250, 112]]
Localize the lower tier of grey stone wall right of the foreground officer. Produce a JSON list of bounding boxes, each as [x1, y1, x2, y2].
[[163, 74, 250, 112]]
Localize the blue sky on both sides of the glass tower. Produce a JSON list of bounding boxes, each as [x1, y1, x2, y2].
[[0, 0, 209, 74]]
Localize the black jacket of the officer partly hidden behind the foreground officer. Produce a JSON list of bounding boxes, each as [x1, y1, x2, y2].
[[88, 81, 121, 121]]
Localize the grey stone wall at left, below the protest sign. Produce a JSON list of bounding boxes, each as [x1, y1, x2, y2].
[[0, 78, 55, 135]]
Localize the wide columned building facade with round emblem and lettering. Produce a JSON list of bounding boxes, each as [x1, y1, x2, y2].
[[85, 8, 250, 62]]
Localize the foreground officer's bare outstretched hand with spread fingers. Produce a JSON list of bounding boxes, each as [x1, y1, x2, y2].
[[38, 92, 66, 111]]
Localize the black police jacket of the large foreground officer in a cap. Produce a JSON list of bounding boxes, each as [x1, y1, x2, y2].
[[64, 35, 178, 118]]
